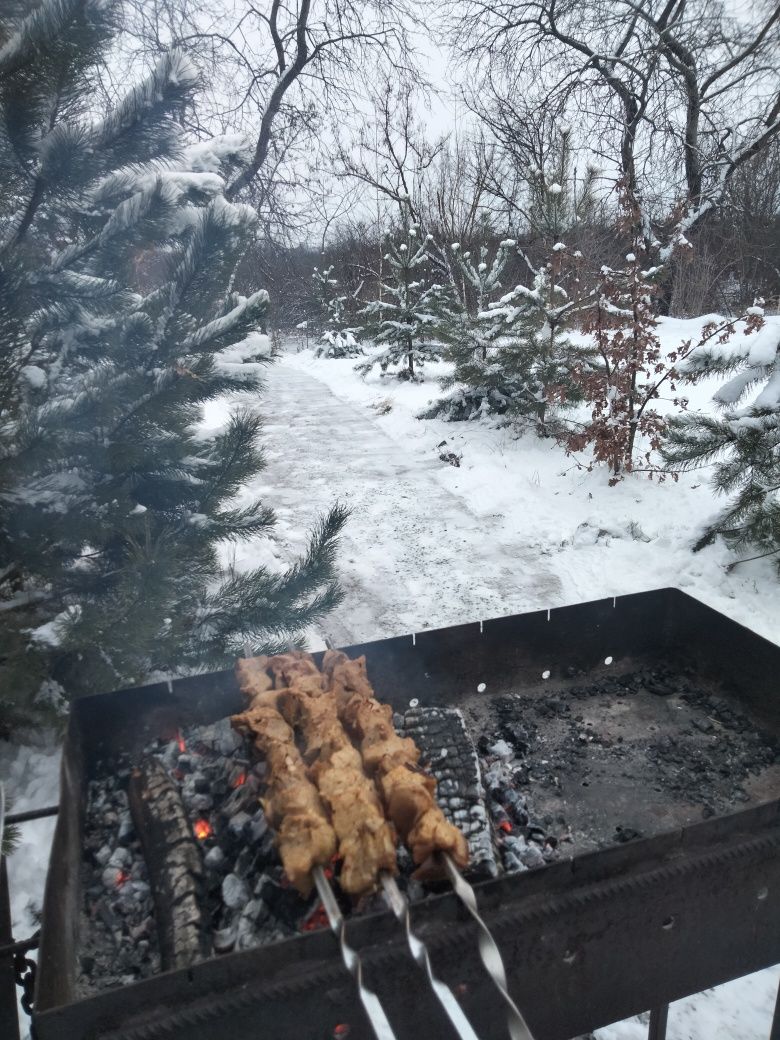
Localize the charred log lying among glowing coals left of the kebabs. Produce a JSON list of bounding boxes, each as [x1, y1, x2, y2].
[[129, 762, 211, 971]]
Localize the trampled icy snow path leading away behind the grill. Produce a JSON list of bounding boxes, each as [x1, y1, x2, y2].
[[243, 359, 561, 645]]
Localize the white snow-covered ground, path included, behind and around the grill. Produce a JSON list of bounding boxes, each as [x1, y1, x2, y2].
[[0, 318, 780, 1040]]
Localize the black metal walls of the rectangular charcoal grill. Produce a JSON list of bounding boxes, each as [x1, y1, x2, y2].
[[0, 589, 780, 1040]]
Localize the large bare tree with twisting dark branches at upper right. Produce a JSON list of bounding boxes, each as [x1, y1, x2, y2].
[[448, 0, 780, 289]]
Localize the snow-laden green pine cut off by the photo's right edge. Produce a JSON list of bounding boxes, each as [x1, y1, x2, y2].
[[662, 305, 780, 568]]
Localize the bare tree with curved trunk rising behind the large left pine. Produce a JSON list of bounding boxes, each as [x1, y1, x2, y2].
[[103, 0, 422, 231]]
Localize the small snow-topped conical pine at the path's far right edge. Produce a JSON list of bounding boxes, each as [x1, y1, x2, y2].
[[356, 226, 449, 380]]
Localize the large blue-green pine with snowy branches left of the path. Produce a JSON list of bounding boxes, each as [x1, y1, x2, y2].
[[0, 0, 344, 722]]
